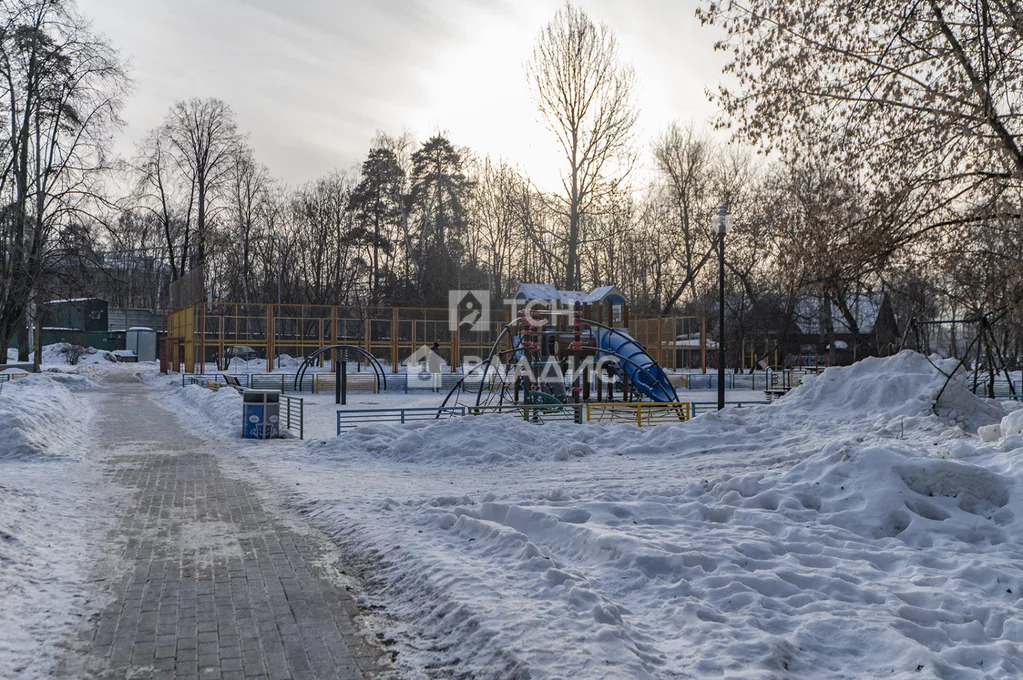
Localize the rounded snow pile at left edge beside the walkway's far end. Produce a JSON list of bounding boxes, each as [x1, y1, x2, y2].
[[0, 373, 90, 460]]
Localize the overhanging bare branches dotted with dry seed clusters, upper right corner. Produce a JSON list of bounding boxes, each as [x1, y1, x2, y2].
[[698, 0, 1023, 229]]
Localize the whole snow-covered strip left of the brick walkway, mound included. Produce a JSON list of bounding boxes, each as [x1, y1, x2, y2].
[[0, 374, 102, 678]]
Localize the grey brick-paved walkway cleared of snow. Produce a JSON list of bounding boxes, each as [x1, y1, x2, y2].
[[58, 383, 377, 680]]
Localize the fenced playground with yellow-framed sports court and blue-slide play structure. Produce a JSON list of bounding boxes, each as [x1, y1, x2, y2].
[[165, 284, 797, 437]]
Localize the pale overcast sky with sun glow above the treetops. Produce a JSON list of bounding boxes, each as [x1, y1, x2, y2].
[[79, 0, 723, 186]]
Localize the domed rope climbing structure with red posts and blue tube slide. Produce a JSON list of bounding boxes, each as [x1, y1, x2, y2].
[[438, 299, 685, 420]]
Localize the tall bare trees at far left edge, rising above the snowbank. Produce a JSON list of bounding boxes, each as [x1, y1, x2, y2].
[[0, 0, 125, 363]]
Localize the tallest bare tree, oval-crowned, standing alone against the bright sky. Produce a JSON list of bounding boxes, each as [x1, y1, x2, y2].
[[527, 4, 636, 289]]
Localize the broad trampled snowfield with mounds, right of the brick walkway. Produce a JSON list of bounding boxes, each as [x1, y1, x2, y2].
[[163, 353, 1023, 680]]
